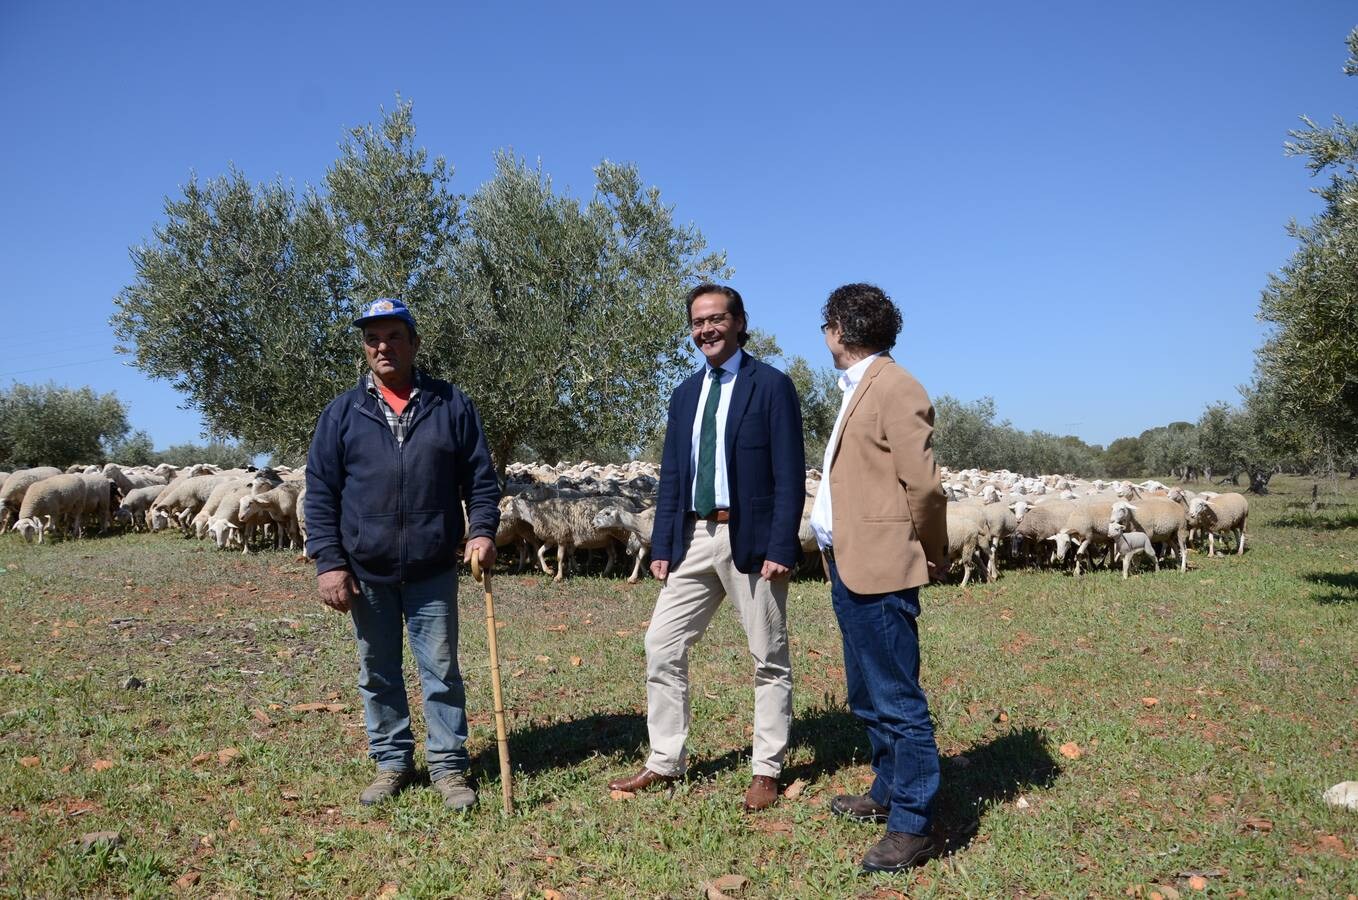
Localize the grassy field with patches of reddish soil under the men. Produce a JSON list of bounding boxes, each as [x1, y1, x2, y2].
[[0, 478, 1358, 897]]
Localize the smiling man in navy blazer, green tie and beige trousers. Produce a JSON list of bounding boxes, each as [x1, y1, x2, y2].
[[608, 284, 807, 812]]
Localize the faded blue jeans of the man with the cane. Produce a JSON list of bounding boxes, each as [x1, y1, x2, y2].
[[352, 569, 469, 781]]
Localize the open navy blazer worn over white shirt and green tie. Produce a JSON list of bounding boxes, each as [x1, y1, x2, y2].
[[650, 353, 807, 574]]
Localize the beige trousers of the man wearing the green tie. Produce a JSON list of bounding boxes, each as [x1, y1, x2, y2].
[[646, 521, 792, 778]]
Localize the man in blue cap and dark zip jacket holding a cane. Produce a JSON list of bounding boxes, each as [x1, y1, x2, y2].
[[306, 300, 500, 809]]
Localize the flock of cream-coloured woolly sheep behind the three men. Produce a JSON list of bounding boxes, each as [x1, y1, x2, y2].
[[0, 462, 1249, 585]]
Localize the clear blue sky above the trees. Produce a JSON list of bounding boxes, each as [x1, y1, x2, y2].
[[0, 0, 1358, 447]]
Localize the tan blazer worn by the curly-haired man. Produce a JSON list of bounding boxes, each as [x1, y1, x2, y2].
[[827, 353, 948, 593]]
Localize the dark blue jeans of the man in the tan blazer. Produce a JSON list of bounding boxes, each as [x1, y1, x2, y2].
[[830, 562, 938, 835]]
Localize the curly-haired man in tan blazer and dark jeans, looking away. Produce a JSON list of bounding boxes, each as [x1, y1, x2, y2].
[[811, 284, 948, 871]]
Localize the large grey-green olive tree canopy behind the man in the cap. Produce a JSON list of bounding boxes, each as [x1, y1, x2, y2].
[[113, 102, 729, 467]]
